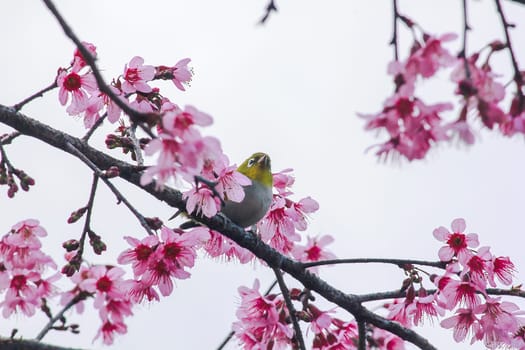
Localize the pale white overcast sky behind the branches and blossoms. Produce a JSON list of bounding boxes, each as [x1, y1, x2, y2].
[[0, 0, 525, 349]]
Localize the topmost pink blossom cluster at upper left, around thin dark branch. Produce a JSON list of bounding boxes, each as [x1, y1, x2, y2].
[[56, 42, 192, 128]]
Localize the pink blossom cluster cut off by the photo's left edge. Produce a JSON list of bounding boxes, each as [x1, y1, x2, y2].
[[0, 219, 60, 318]]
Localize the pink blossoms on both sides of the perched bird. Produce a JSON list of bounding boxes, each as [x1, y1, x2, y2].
[[184, 168, 326, 263]]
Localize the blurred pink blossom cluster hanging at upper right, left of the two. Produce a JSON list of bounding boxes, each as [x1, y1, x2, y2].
[[361, 34, 455, 160]]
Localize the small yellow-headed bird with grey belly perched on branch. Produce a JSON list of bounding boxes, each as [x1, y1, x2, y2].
[[221, 152, 273, 227]]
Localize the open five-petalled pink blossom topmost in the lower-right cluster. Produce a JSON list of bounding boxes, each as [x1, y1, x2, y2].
[[433, 218, 479, 264]]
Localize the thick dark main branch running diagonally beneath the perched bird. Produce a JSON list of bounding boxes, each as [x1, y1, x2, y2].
[[0, 105, 435, 349]]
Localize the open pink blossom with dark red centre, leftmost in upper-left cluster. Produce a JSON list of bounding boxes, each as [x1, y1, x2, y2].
[[57, 69, 97, 115]]
